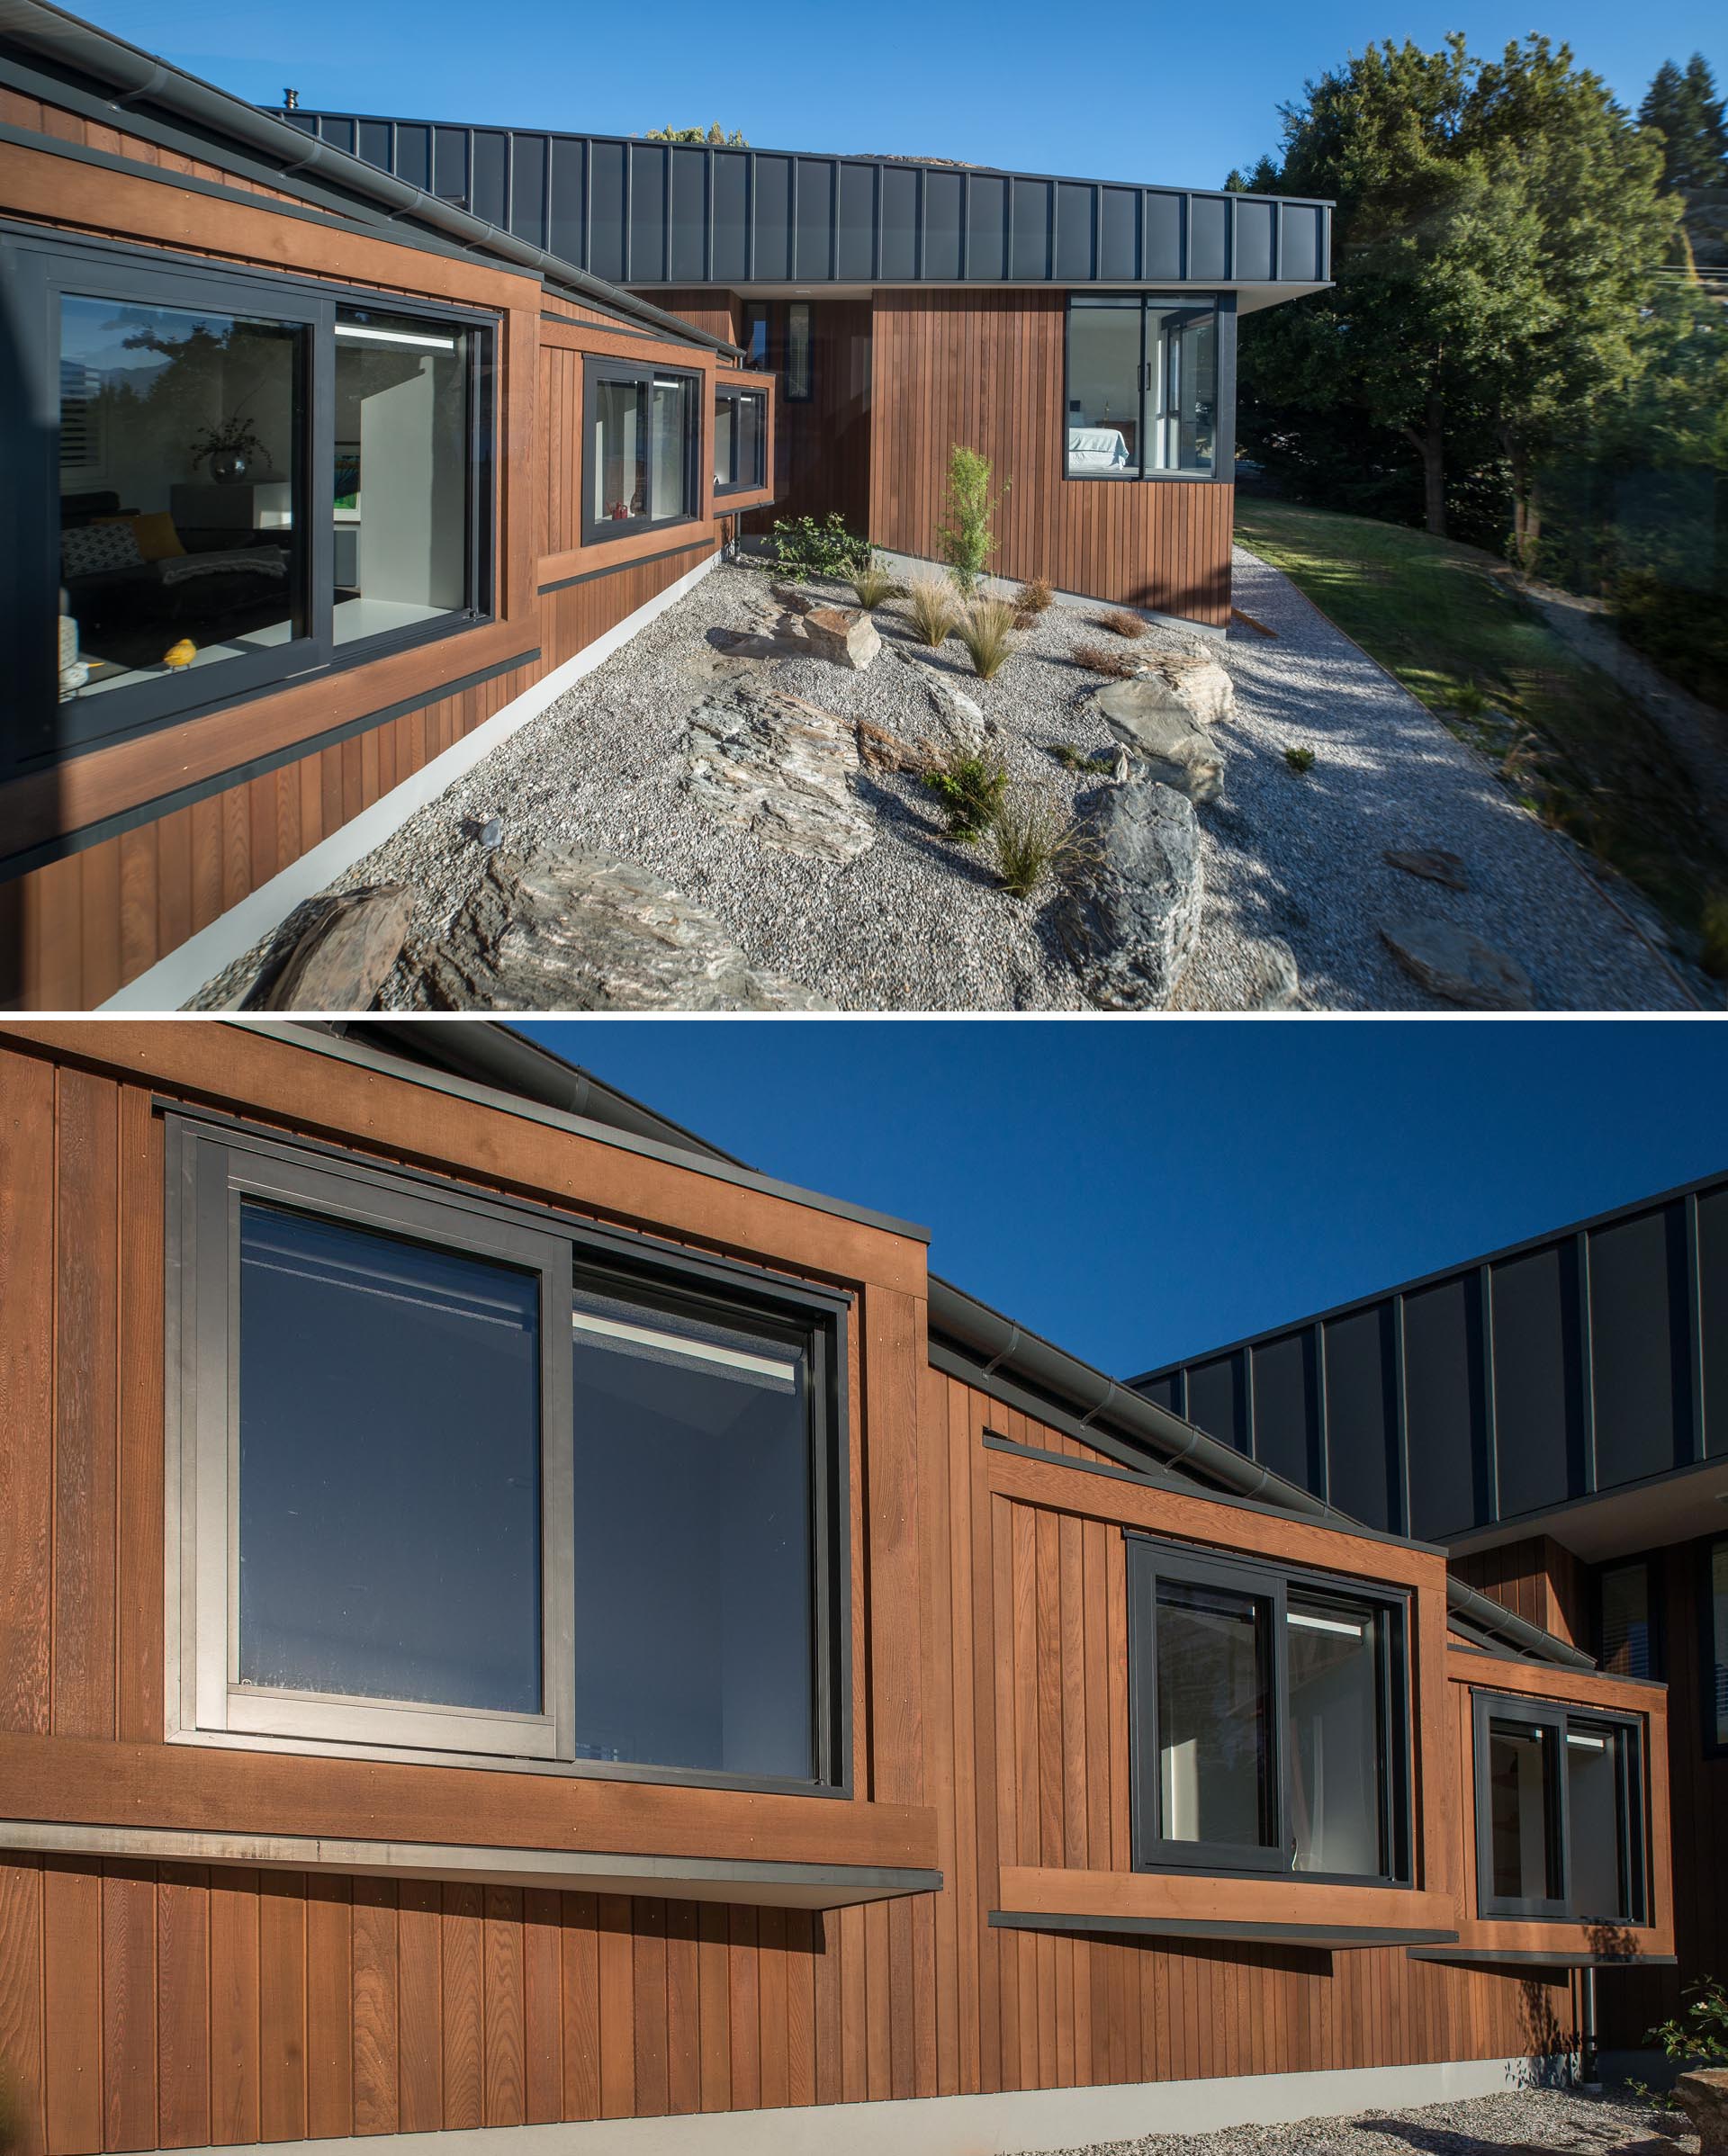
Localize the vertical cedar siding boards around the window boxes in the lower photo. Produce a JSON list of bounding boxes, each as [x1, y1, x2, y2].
[[0, 1038, 1622, 2156]]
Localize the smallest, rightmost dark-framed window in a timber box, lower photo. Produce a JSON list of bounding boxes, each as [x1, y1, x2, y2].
[[1473, 1693, 1646, 1923]]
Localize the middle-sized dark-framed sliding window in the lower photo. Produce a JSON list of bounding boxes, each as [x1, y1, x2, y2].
[[1129, 1537, 1408, 1880]]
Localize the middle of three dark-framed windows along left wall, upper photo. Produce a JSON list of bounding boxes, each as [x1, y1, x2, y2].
[[582, 358, 701, 545]]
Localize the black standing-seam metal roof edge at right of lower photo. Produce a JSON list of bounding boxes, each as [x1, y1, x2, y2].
[[1130, 1172, 1728, 1544]]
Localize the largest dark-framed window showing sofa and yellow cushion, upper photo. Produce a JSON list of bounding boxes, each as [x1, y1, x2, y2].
[[0, 241, 492, 768]]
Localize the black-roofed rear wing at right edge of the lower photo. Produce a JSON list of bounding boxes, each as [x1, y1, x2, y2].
[[1132, 1175, 1728, 2048]]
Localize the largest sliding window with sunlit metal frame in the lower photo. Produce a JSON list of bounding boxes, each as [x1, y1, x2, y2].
[[170, 1119, 846, 1790]]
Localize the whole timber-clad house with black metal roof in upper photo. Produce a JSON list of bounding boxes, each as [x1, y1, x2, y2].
[[0, 0, 1329, 1009]]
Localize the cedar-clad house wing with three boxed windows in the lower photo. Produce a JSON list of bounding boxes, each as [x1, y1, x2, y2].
[[0, 1018, 1697, 2156]]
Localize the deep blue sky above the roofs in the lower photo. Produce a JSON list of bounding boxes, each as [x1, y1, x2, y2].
[[522, 1020, 1728, 1376]]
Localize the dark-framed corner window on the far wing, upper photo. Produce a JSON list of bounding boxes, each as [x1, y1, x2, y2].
[[1064, 295, 1234, 479]]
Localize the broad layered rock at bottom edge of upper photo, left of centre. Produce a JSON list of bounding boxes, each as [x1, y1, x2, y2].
[[417, 851, 835, 1011]]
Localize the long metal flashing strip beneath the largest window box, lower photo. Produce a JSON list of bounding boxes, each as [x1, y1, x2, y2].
[[0, 1819, 942, 1908]]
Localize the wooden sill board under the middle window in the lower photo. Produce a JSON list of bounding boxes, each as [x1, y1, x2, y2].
[[993, 1865, 1458, 1945]]
